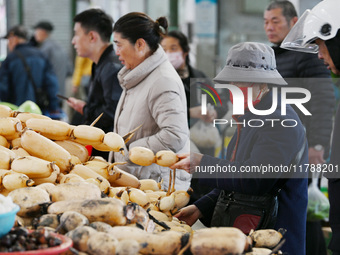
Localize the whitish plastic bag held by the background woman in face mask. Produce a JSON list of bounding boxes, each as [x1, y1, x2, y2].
[[190, 120, 221, 148]]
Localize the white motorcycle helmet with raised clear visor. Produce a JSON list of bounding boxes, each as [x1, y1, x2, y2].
[[280, 0, 340, 53]]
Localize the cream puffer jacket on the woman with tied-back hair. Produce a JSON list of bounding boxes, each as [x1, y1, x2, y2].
[[114, 46, 191, 190]]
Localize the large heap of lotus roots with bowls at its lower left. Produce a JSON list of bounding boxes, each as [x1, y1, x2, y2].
[[0, 105, 285, 254]]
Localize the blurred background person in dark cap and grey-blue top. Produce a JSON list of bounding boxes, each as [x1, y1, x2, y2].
[[34, 21, 71, 95]]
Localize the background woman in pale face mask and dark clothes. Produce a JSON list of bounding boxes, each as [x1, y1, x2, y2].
[[161, 31, 228, 203]]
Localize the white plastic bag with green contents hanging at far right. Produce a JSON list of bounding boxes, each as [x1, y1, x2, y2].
[[307, 172, 329, 221]]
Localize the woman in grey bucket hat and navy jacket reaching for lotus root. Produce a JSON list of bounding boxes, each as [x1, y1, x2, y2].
[[172, 42, 308, 254]]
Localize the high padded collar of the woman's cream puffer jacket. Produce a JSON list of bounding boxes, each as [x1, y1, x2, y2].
[[118, 45, 168, 89]]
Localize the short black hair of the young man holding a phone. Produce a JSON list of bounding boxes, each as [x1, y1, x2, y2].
[[73, 9, 113, 42]]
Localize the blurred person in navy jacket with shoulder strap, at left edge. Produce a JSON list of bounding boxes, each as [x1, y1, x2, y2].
[[0, 26, 59, 112]]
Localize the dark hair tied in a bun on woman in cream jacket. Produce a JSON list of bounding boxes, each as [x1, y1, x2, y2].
[[113, 12, 168, 52]]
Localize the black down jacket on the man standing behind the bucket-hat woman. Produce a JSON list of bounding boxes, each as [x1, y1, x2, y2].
[[273, 46, 335, 158]]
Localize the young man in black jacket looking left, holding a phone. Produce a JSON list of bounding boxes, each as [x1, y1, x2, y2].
[[67, 9, 122, 159]]
